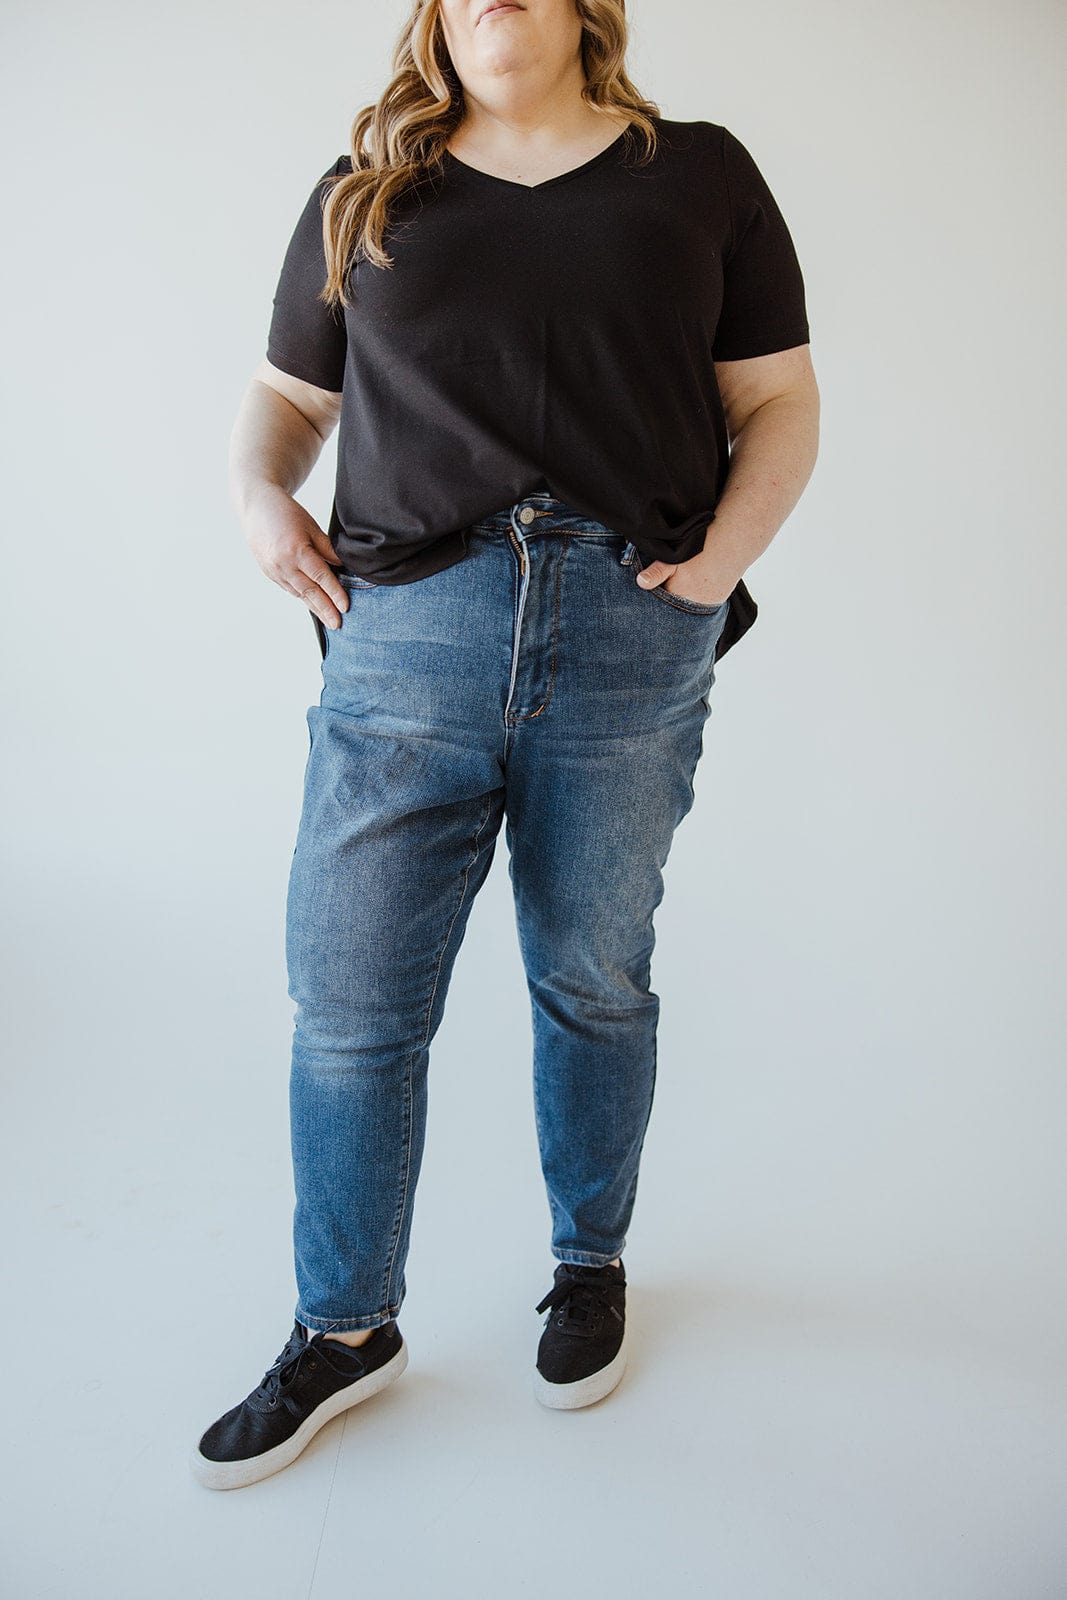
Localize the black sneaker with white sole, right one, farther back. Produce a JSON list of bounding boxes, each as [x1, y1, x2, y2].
[[534, 1261, 625, 1411]]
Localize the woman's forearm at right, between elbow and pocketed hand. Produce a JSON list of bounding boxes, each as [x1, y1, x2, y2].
[[693, 392, 819, 594]]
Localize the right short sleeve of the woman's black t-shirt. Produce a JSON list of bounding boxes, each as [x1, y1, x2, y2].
[[712, 128, 809, 362]]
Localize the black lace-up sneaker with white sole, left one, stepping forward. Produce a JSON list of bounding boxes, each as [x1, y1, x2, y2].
[[189, 1322, 408, 1490]]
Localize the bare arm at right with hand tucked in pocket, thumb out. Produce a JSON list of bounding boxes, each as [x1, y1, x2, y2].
[[637, 344, 819, 603]]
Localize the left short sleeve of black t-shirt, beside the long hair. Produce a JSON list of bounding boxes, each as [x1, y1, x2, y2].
[[267, 155, 352, 394]]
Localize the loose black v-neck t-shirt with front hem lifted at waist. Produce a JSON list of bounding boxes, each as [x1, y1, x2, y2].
[[267, 117, 808, 630]]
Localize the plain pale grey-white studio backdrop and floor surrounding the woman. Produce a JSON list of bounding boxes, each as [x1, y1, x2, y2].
[[0, 0, 1067, 1600]]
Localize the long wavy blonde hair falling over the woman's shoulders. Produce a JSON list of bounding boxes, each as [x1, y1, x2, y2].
[[318, 0, 659, 306]]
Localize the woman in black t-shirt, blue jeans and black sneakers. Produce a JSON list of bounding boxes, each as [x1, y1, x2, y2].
[[192, 0, 819, 1488]]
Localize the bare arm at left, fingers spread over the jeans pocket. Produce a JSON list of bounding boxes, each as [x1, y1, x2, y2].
[[229, 362, 349, 627]]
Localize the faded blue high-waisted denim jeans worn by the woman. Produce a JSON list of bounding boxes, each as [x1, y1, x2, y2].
[[286, 494, 731, 1330]]
